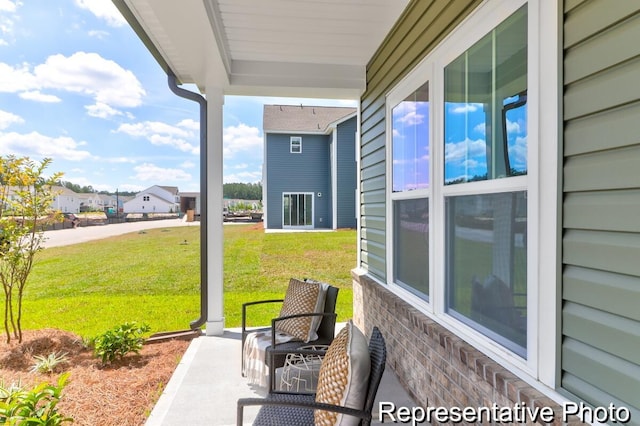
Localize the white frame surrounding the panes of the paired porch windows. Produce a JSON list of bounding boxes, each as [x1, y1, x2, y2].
[[386, 0, 561, 389]]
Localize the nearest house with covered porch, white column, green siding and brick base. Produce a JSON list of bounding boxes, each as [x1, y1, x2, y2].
[[115, 0, 640, 425]]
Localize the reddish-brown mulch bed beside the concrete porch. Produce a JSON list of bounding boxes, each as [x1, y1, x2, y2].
[[0, 329, 189, 426]]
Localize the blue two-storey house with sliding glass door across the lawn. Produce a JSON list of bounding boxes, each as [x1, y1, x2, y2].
[[262, 105, 356, 229]]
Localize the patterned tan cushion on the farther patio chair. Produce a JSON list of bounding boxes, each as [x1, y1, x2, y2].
[[276, 278, 329, 342]]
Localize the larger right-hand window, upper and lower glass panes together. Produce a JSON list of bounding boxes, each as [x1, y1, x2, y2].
[[444, 6, 527, 358]]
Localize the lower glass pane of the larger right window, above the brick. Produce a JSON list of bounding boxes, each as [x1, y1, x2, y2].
[[445, 191, 527, 357]]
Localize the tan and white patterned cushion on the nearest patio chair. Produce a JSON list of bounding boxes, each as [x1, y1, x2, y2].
[[314, 321, 371, 426]]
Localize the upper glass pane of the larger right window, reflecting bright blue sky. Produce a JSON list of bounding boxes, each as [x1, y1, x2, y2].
[[444, 6, 527, 184]]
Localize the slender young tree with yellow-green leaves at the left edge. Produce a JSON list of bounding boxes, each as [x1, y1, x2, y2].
[[0, 155, 62, 343]]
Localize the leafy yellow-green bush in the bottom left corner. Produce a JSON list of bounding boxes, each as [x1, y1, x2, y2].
[[0, 373, 73, 426]]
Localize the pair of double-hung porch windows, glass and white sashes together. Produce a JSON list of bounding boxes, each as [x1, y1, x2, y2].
[[387, 0, 537, 365]]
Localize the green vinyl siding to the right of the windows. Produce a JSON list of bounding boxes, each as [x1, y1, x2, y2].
[[561, 0, 640, 416]]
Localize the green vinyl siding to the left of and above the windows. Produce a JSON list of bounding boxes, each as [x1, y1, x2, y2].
[[359, 0, 481, 280]]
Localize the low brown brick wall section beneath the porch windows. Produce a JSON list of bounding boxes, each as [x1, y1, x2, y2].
[[352, 270, 582, 425]]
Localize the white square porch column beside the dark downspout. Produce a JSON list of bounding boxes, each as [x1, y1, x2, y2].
[[205, 87, 224, 336]]
